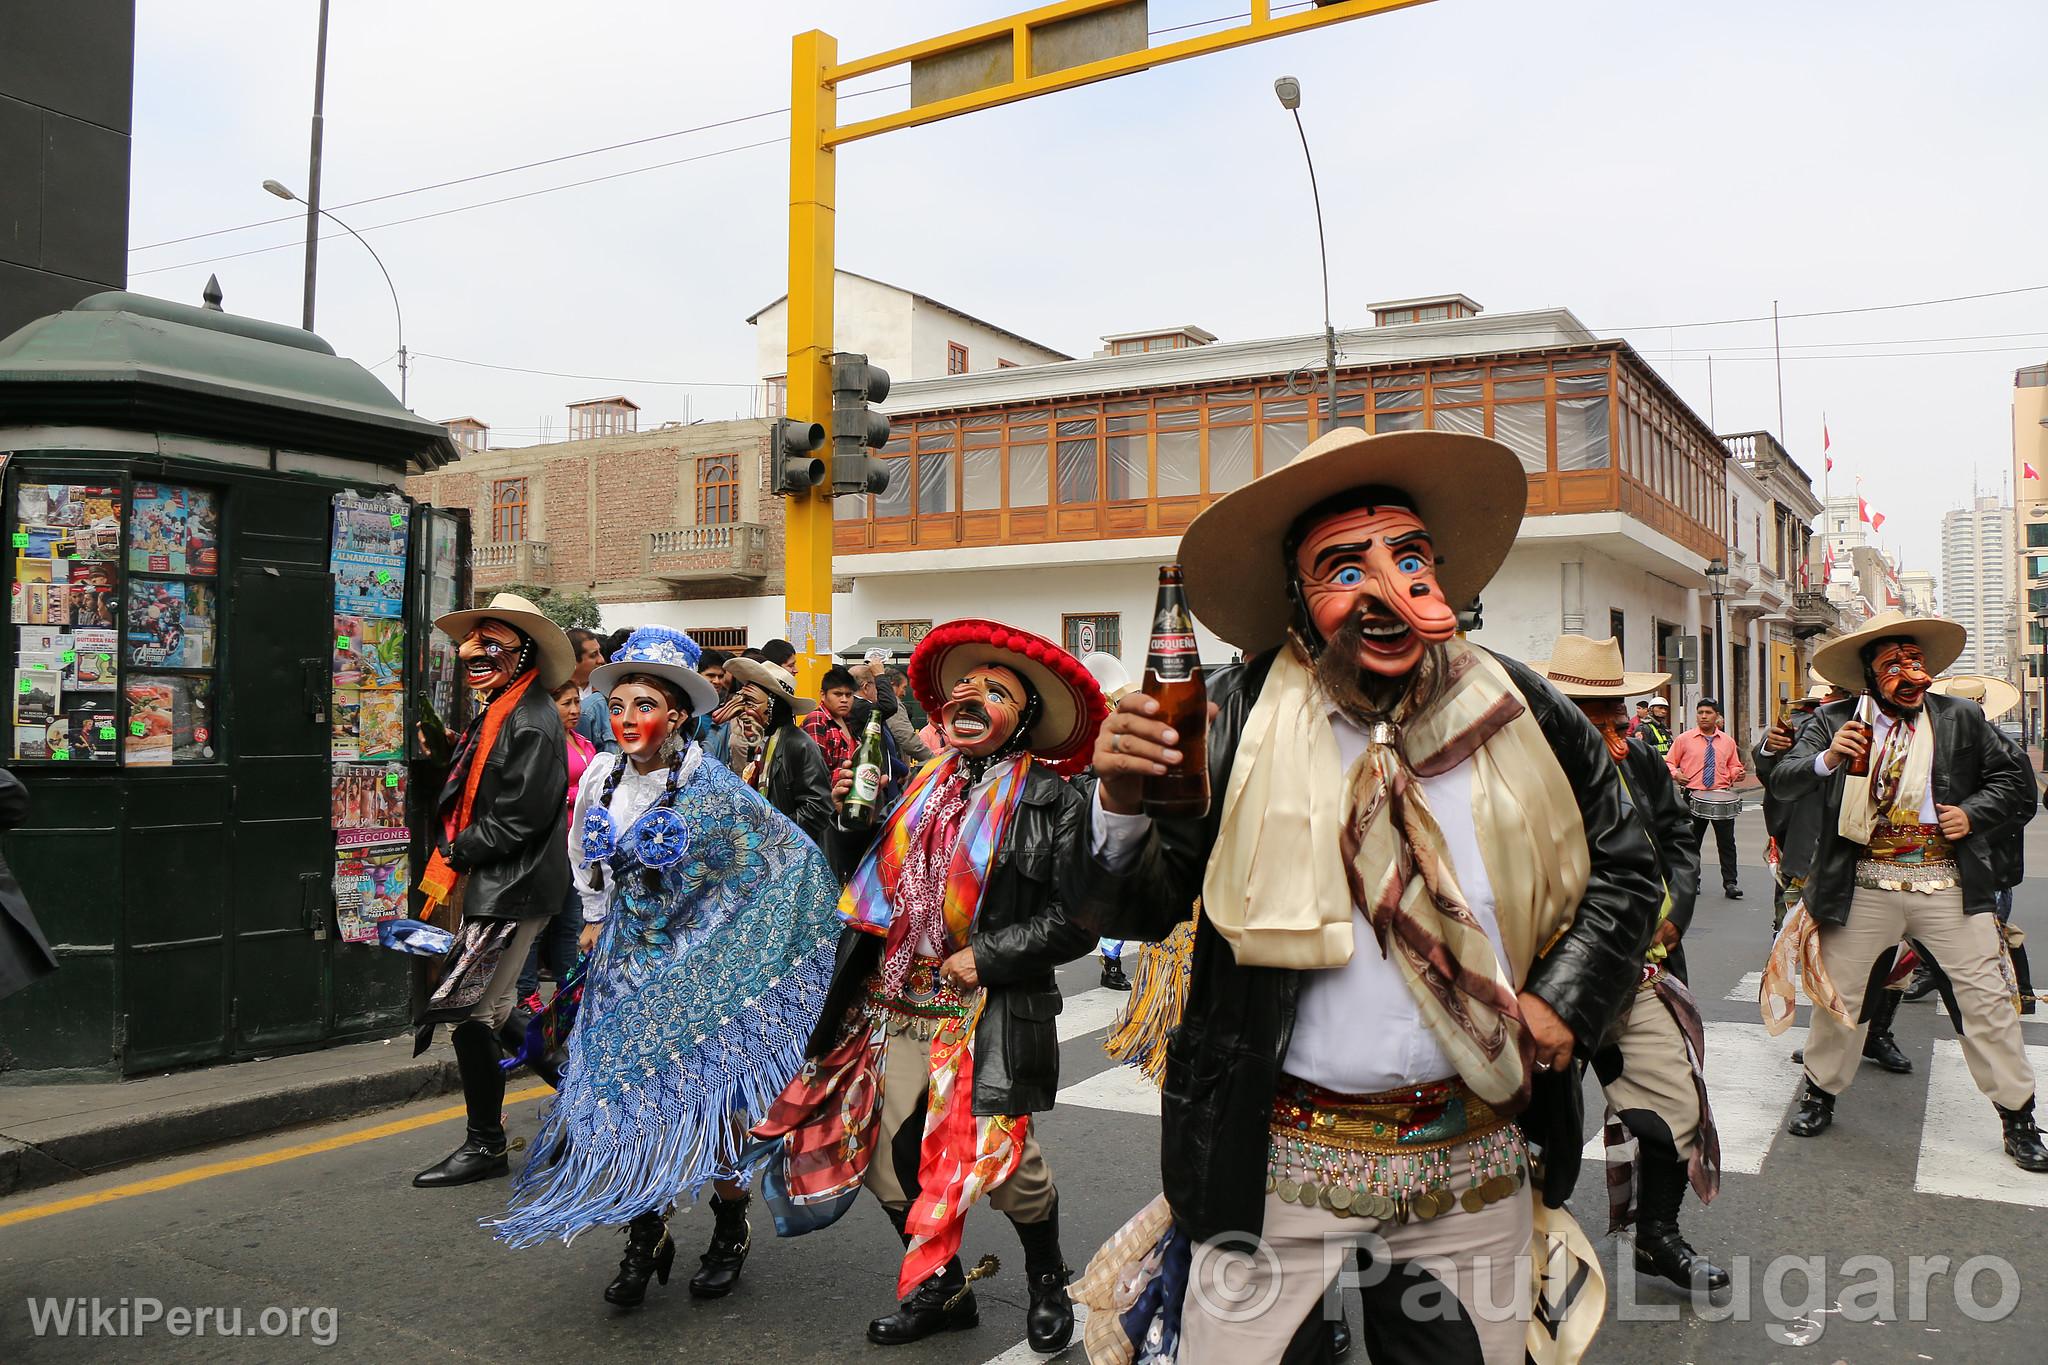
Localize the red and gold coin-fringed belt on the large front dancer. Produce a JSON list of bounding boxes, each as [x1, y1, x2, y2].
[[1266, 1076, 1528, 1224]]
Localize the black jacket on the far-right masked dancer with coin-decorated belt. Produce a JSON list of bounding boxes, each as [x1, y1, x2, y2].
[[1769, 694, 2034, 925]]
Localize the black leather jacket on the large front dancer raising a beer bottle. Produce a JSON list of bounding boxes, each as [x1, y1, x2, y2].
[[1061, 655, 1663, 1240]]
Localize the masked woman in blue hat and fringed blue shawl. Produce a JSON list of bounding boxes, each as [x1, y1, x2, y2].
[[492, 626, 840, 1308]]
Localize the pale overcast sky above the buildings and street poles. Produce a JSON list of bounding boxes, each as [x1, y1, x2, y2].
[[129, 0, 2048, 569]]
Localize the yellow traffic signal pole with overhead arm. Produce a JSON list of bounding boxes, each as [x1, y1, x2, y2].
[[782, 0, 1427, 696]]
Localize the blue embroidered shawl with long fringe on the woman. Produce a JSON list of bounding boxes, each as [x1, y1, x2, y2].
[[485, 761, 840, 1246]]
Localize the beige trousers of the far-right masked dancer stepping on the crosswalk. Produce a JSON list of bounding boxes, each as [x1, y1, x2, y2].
[[1806, 886, 2034, 1109]]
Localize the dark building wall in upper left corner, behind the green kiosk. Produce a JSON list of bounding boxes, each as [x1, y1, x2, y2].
[[0, 0, 132, 336]]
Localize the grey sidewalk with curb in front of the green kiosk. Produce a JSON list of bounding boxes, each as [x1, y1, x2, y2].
[[0, 1029, 461, 1195]]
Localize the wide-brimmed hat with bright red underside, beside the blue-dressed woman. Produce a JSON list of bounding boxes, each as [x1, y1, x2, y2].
[[909, 618, 1110, 767]]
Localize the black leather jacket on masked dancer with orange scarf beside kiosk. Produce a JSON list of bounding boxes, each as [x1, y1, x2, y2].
[[436, 679, 569, 919]]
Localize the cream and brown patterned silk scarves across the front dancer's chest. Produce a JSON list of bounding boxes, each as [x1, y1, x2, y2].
[[1202, 641, 1589, 1105]]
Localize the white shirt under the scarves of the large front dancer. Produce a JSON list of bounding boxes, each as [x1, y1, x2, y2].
[[1090, 710, 1507, 1095]]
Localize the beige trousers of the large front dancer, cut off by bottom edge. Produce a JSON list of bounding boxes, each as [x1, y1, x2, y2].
[[1180, 1150, 1532, 1365]]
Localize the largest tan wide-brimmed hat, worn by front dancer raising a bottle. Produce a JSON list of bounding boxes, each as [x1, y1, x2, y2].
[[1180, 428, 1530, 653]]
